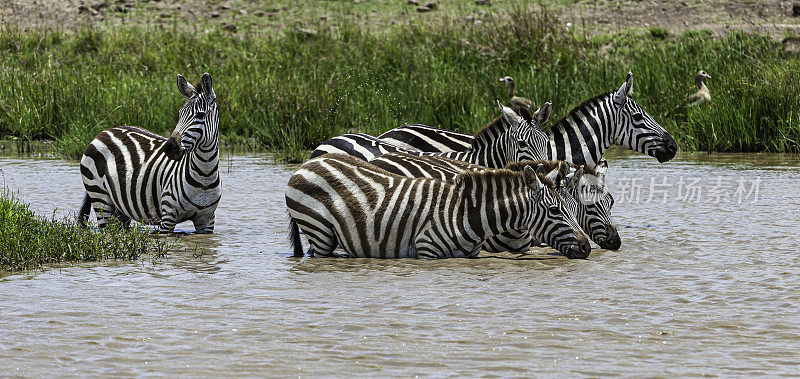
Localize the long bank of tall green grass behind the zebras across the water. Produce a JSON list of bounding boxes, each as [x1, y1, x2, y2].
[[0, 8, 800, 159]]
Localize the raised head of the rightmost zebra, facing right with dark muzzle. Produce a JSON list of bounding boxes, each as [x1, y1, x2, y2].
[[612, 72, 678, 163]]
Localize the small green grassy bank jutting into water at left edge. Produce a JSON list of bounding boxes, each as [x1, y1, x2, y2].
[[0, 190, 166, 272]]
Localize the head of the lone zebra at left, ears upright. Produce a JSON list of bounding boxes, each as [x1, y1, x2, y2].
[[164, 73, 219, 160]]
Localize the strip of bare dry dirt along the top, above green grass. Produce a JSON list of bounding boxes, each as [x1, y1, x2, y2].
[[0, 0, 800, 39]]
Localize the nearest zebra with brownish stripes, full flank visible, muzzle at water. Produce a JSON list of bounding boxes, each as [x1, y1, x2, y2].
[[286, 154, 588, 258]]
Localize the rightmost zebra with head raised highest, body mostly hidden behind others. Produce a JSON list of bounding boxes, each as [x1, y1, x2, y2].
[[378, 72, 678, 169]]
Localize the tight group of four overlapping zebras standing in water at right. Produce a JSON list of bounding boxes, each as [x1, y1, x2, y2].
[[286, 72, 677, 258]]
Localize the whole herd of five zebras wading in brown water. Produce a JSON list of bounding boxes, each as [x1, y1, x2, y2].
[[73, 73, 677, 258]]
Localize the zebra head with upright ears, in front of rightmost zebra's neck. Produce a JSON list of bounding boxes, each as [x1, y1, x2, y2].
[[497, 101, 553, 163]]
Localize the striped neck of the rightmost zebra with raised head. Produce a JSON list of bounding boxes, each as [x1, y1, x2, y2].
[[547, 93, 618, 168]]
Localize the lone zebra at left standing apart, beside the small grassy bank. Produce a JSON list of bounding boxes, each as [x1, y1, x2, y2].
[[78, 73, 220, 233]]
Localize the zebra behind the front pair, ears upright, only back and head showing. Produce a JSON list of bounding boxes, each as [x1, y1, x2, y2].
[[311, 101, 552, 168]]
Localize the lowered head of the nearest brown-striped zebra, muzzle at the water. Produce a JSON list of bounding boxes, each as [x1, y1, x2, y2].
[[523, 165, 591, 259]]
